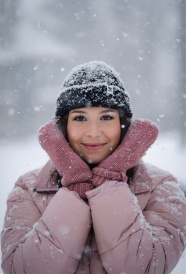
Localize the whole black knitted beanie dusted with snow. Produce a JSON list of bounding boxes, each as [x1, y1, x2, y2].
[[55, 61, 132, 119]]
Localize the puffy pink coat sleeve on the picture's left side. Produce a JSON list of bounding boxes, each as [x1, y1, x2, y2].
[[1, 177, 91, 274]]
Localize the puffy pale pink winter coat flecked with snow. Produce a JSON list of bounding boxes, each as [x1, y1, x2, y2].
[[1, 161, 186, 274]]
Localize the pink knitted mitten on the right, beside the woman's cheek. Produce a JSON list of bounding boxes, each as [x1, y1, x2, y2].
[[92, 119, 158, 186]]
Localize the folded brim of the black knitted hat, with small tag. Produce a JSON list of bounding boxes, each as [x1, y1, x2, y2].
[[55, 84, 132, 118]]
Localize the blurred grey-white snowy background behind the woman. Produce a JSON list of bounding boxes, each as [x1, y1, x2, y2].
[[0, 0, 186, 274]]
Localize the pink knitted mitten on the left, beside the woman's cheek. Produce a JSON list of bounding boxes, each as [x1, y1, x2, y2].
[[38, 123, 94, 198]]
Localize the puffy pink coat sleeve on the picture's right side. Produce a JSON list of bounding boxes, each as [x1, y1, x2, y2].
[[87, 178, 186, 274]]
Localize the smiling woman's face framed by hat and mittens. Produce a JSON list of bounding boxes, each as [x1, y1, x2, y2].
[[67, 107, 121, 164]]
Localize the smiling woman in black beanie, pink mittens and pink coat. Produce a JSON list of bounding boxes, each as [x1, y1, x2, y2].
[[2, 61, 186, 274]]
